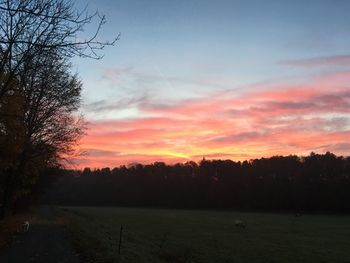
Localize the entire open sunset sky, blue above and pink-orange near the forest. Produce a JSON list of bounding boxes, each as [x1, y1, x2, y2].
[[73, 0, 350, 168]]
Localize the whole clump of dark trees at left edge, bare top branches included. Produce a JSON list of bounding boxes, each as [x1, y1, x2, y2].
[[0, 0, 119, 218]]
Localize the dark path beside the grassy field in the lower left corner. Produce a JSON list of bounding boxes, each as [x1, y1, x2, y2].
[[0, 206, 81, 263]]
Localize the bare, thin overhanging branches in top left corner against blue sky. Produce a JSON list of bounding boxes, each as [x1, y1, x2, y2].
[[0, 0, 119, 99]]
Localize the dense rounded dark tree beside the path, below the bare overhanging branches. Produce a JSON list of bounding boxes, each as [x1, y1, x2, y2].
[[1, 54, 82, 217]]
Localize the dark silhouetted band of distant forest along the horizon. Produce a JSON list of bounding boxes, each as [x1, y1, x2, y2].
[[43, 152, 350, 213]]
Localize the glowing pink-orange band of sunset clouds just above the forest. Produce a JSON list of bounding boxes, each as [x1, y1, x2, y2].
[[76, 72, 350, 167]]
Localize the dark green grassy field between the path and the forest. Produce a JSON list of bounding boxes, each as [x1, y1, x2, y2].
[[61, 207, 350, 263]]
